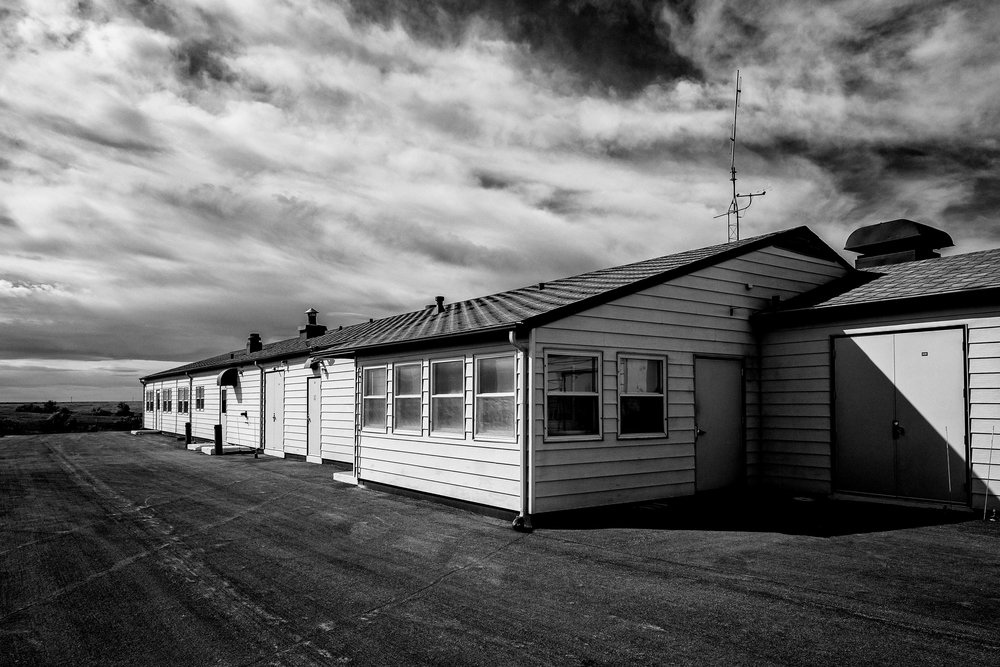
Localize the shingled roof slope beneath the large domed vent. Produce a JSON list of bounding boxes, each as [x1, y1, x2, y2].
[[808, 249, 1000, 309]]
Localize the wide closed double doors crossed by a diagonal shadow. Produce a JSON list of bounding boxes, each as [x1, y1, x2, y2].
[[834, 329, 968, 502]]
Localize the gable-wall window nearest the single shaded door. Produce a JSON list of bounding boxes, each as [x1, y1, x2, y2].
[[618, 356, 667, 435]]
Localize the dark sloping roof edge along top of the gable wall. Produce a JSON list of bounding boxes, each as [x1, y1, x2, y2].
[[524, 225, 844, 328]]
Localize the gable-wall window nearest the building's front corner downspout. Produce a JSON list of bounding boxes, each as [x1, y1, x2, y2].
[[545, 354, 601, 437]]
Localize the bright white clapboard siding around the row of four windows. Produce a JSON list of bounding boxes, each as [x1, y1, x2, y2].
[[354, 344, 523, 510]]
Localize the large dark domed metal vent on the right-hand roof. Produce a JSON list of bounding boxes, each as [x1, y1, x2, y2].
[[844, 219, 955, 269]]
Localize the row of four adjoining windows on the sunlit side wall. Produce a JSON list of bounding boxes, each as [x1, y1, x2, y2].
[[361, 354, 516, 439]]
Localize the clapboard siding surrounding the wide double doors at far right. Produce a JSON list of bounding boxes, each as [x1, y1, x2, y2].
[[760, 309, 1000, 507]]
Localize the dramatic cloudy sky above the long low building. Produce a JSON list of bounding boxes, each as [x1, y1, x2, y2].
[[0, 0, 1000, 401]]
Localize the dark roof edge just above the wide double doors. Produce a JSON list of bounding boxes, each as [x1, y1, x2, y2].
[[753, 287, 1000, 330]]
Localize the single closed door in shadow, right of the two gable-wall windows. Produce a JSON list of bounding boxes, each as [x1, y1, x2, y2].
[[694, 357, 746, 491]]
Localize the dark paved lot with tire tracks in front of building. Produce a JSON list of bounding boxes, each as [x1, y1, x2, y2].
[[0, 433, 1000, 665]]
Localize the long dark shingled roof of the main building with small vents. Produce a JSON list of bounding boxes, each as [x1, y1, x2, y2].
[[143, 227, 846, 380]]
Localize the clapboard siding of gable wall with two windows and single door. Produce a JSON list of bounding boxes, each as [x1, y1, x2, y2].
[[532, 248, 845, 512]]
